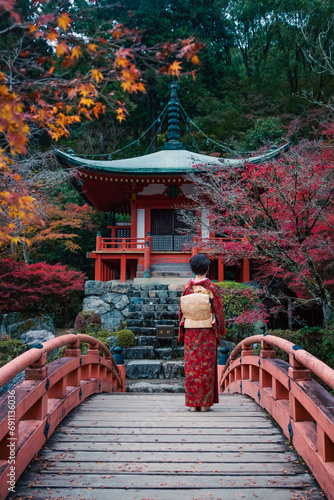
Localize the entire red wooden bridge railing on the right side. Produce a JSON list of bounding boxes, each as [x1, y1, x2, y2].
[[219, 335, 334, 500]]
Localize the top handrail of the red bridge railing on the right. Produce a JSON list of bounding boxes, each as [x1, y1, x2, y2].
[[223, 334, 334, 389]]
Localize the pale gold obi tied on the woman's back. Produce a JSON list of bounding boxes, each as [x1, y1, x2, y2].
[[181, 285, 214, 328]]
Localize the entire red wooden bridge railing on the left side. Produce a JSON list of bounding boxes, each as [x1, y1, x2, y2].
[[0, 334, 125, 499]]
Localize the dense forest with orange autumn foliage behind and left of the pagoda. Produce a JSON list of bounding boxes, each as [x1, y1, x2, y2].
[[0, 0, 334, 366]]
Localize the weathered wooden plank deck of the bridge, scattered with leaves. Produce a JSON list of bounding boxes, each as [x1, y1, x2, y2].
[[10, 393, 325, 500]]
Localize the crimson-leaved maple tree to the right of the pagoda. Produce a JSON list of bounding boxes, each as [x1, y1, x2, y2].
[[187, 142, 334, 325]]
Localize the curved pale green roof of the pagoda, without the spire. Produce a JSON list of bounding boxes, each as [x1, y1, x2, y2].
[[54, 143, 290, 175]]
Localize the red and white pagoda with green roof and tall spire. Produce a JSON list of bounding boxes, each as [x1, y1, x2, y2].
[[55, 82, 285, 283]]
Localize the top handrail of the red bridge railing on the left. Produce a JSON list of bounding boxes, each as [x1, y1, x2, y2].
[[0, 333, 117, 387]]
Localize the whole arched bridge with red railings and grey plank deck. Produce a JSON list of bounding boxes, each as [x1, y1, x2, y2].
[[0, 334, 334, 500]]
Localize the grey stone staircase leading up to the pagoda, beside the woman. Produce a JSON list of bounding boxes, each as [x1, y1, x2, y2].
[[111, 284, 184, 392]]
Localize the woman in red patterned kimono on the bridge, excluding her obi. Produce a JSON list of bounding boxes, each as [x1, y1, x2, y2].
[[178, 254, 226, 411]]
